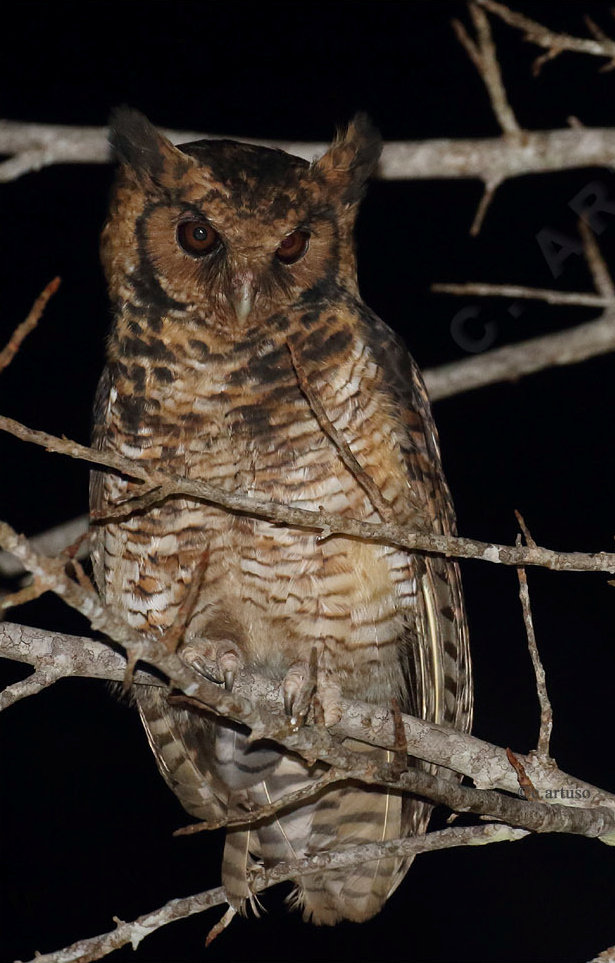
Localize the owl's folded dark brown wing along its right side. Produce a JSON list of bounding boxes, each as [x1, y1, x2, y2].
[[362, 308, 472, 731]]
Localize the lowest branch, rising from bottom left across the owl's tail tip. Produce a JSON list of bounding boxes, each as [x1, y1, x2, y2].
[[21, 825, 526, 963]]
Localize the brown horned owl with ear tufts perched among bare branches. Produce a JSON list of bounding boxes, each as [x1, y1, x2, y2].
[[91, 109, 472, 925]]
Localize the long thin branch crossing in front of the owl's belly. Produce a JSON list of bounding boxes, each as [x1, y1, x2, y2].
[[0, 412, 615, 574]]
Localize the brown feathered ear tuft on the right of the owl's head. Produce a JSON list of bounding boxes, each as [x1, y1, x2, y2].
[[314, 113, 382, 204]]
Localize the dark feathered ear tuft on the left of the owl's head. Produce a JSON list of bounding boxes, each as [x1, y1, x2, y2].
[[109, 107, 189, 181]]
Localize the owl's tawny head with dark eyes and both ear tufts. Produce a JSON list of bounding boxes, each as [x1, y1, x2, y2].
[[102, 108, 381, 329]]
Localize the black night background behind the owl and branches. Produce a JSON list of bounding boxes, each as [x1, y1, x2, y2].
[[0, 0, 615, 963]]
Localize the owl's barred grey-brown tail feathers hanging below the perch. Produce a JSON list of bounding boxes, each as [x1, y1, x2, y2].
[[222, 743, 422, 926]]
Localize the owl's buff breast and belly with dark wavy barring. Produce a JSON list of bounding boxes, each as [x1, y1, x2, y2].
[[97, 324, 416, 699]]
